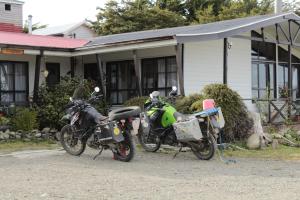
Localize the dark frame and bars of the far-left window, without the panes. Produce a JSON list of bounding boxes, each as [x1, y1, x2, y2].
[[0, 60, 29, 105]]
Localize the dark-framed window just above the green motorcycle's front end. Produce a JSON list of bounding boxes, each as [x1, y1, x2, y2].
[[142, 57, 177, 96]]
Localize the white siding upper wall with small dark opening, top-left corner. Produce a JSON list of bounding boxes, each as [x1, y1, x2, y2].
[[0, 2, 23, 27]]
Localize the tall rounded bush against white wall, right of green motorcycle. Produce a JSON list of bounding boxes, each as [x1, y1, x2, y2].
[[202, 84, 253, 142]]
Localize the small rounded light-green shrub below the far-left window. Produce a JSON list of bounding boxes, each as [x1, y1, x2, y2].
[[11, 108, 38, 131]]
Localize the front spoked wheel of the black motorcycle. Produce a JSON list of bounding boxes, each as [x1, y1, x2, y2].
[[60, 125, 86, 156]]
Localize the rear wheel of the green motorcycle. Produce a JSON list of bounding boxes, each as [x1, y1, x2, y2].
[[190, 134, 216, 160]]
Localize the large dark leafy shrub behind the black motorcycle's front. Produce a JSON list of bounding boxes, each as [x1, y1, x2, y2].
[[35, 77, 107, 129]]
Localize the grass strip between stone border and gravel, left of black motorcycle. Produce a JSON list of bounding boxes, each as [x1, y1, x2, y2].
[[0, 140, 58, 153]]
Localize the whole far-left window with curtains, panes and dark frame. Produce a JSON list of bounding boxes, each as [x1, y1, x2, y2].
[[0, 62, 28, 105]]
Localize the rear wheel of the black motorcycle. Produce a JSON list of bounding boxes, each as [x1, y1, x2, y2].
[[114, 131, 134, 162]]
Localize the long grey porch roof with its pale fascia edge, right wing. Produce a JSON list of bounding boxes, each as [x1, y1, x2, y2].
[[83, 13, 300, 49]]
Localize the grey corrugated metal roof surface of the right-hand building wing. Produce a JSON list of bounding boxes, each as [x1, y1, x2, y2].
[[86, 13, 300, 47]]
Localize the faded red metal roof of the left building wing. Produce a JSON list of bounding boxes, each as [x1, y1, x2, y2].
[[0, 32, 88, 49]]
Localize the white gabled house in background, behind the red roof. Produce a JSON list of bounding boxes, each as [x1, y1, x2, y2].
[[32, 21, 96, 39]]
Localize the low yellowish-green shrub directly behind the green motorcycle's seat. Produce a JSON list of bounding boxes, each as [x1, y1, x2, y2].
[[175, 94, 203, 114]]
